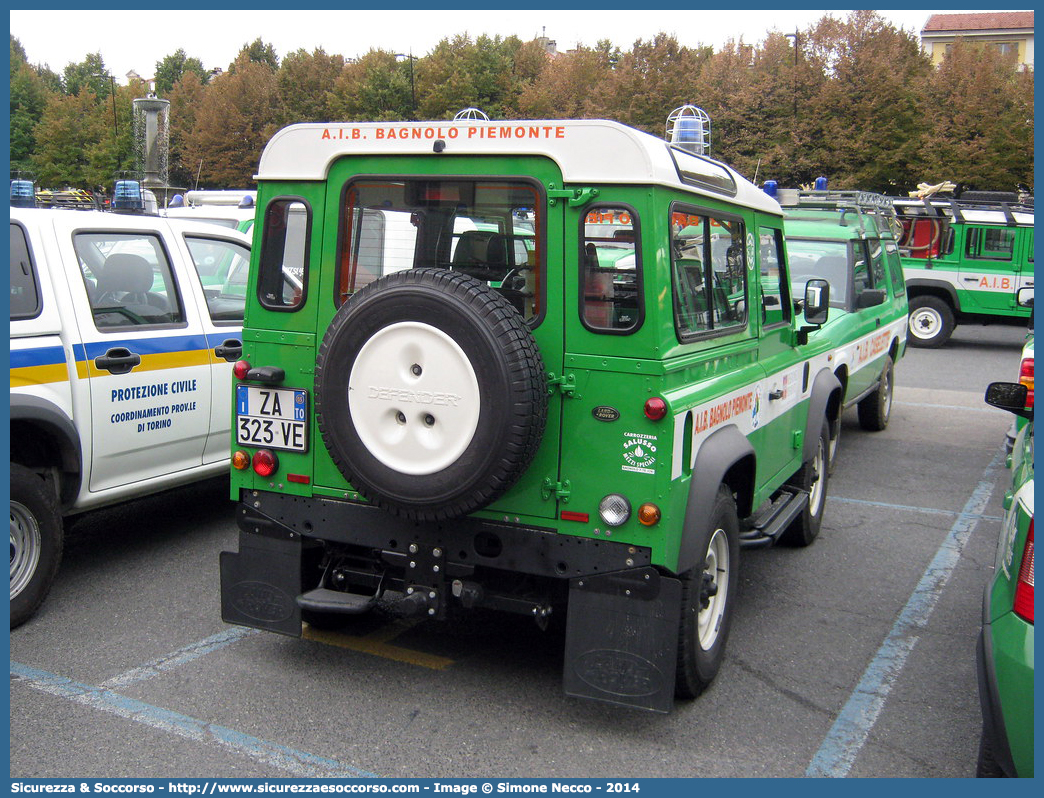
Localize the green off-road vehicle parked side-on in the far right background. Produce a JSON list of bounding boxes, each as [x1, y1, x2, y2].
[[894, 191, 1034, 348]]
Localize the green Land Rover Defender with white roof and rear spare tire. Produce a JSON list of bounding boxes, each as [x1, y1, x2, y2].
[[221, 113, 841, 711]]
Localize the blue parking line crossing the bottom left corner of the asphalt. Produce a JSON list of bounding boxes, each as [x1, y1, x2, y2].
[[10, 661, 380, 778]]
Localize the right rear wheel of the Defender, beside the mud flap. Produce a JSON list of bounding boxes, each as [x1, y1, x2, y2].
[[674, 485, 739, 699]]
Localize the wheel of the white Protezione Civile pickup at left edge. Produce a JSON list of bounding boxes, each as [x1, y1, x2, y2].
[[10, 463, 62, 629]]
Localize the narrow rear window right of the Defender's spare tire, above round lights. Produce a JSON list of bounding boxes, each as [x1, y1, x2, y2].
[[580, 206, 641, 332]]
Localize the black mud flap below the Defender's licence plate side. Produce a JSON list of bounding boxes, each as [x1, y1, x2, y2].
[[221, 532, 301, 637]]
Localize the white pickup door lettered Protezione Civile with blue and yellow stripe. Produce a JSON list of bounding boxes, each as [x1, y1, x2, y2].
[[56, 218, 212, 491]]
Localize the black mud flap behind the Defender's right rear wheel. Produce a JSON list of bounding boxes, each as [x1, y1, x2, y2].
[[563, 568, 682, 712]]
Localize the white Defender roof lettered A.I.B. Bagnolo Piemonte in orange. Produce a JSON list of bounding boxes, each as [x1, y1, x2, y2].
[[256, 119, 781, 215]]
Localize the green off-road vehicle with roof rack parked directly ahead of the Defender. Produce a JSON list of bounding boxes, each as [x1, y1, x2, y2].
[[779, 190, 908, 472]]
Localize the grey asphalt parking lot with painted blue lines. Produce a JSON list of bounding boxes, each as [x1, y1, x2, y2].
[[10, 326, 1024, 778]]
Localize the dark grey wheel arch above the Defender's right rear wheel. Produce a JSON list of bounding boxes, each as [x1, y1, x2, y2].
[[678, 424, 757, 573]]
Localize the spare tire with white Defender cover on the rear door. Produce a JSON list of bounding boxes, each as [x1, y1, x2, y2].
[[315, 268, 547, 520]]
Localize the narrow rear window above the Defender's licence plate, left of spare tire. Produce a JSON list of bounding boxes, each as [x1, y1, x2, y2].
[[258, 200, 311, 310]]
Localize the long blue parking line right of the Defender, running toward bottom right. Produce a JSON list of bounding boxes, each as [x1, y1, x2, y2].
[[805, 451, 1004, 778]]
